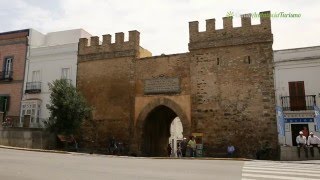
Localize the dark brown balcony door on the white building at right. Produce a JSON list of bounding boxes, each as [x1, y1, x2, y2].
[[289, 81, 306, 111]]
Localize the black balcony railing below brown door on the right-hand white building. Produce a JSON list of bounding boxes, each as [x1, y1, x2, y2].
[[281, 95, 316, 111]]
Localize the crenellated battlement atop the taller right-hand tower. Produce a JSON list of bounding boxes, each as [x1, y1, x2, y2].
[[189, 11, 273, 51]]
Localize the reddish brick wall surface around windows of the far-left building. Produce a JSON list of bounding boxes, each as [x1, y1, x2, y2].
[[0, 31, 28, 116]]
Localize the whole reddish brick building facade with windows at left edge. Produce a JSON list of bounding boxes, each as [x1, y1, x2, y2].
[[0, 29, 29, 122]]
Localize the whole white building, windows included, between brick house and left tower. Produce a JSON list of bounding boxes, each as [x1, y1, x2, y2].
[[21, 29, 91, 127]]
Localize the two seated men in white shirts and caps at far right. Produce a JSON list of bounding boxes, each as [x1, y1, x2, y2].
[[296, 128, 320, 158]]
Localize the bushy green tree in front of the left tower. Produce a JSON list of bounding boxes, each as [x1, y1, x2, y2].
[[47, 79, 92, 135]]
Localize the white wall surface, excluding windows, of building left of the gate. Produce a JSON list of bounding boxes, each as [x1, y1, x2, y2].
[[23, 29, 91, 125]]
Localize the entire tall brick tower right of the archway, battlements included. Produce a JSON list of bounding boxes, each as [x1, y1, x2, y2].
[[189, 11, 277, 157]]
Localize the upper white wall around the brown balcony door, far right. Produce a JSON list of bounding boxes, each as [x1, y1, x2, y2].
[[274, 46, 320, 106]]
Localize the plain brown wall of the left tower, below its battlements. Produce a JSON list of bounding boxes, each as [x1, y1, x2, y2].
[[77, 58, 132, 143]]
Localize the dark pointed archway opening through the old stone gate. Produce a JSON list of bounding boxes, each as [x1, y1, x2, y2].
[[141, 105, 183, 157]]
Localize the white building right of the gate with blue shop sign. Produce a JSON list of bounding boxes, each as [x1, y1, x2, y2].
[[274, 46, 320, 146]]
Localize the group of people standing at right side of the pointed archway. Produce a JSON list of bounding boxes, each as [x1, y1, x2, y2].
[[167, 136, 197, 157]]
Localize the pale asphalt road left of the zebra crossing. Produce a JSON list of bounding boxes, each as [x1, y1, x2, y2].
[[0, 148, 244, 180]]
